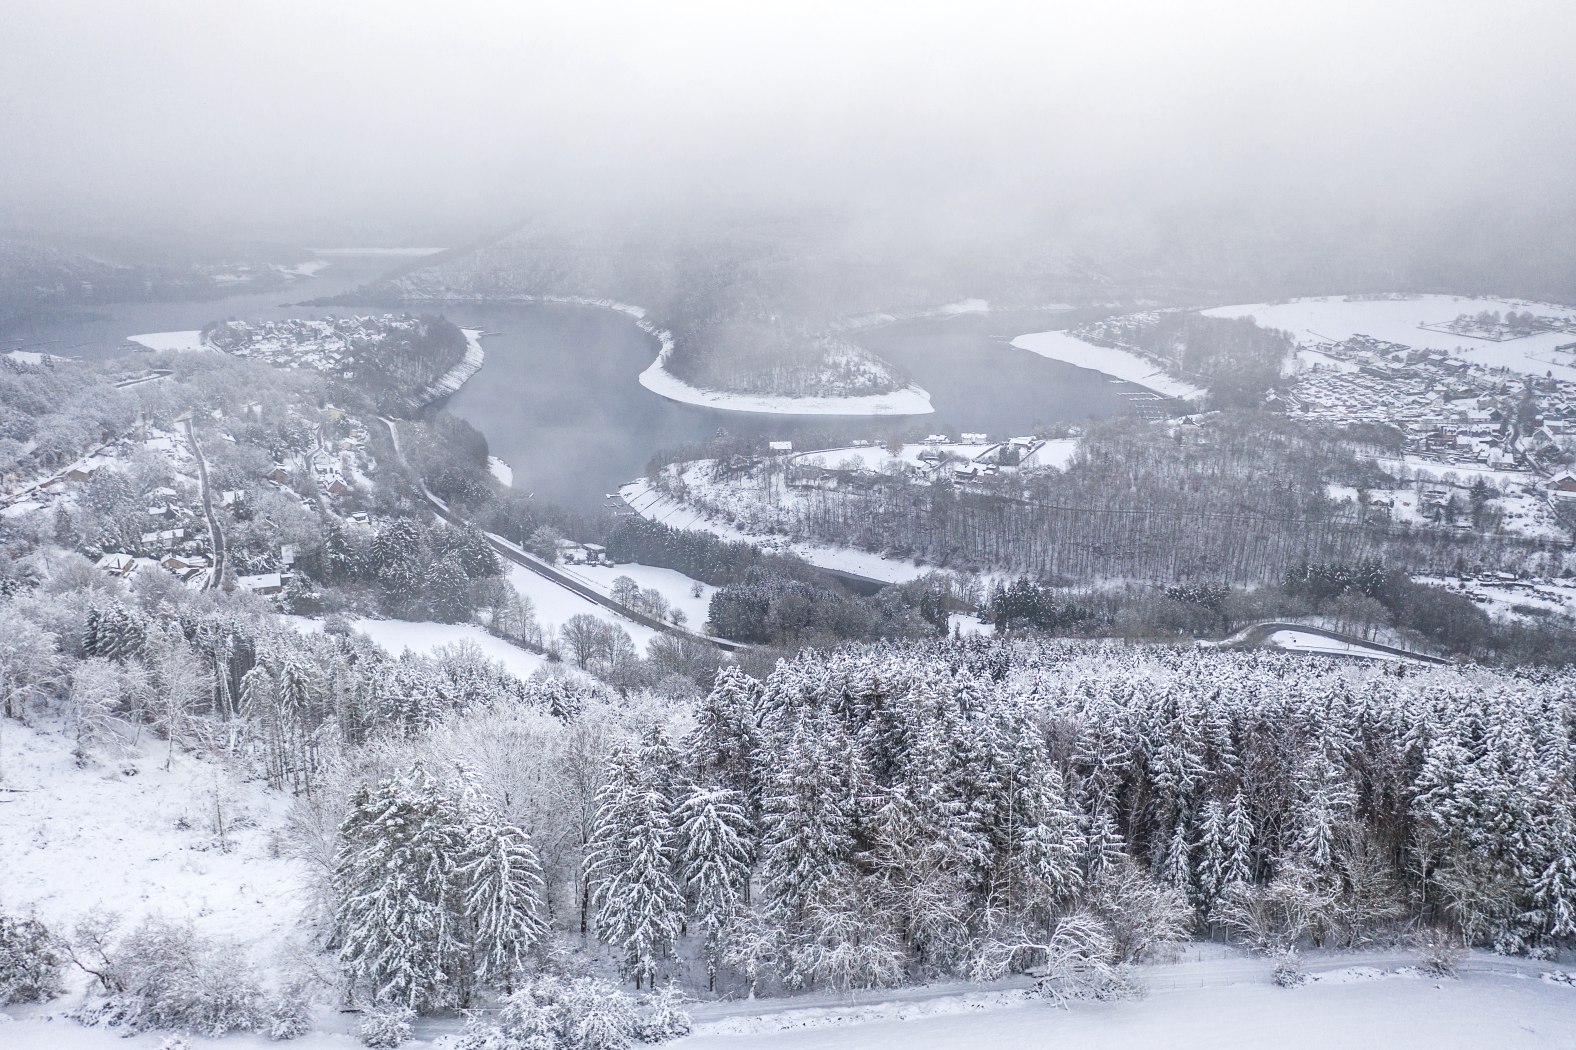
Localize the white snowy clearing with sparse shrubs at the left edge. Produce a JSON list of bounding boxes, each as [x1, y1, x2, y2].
[[0, 719, 299, 958]]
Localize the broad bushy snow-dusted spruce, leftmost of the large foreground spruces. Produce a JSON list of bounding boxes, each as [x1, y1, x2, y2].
[[334, 769, 474, 1011]]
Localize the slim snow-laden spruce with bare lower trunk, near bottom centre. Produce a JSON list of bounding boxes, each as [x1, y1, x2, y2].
[[678, 787, 753, 990]]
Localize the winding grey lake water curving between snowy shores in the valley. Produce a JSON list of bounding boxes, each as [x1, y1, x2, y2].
[[0, 257, 1154, 511]]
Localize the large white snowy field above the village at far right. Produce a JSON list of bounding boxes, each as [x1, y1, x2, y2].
[[1202, 295, 1576, 382]]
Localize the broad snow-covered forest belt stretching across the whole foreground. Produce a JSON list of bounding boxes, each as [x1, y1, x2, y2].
[[0, 572, 1576, 1047]]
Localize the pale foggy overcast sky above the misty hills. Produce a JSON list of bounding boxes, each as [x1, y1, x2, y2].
[[0, 0, 1576, 241]]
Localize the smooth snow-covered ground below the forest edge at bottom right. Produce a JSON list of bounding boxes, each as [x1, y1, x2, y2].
[[671, 957, 1576, 1050]]
